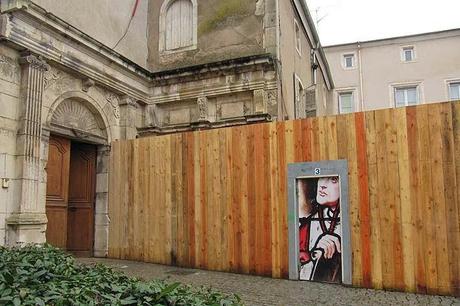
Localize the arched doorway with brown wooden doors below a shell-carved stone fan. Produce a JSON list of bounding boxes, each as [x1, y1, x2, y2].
[[46, 97, 108, 256]]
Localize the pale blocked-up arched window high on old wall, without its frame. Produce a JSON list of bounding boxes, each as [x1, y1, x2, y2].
[[160, 0, 197, 51]]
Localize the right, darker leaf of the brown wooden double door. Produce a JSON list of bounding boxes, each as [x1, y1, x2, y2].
[[67, 143, 96, 256]]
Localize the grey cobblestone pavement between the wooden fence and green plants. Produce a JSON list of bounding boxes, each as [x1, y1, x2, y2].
[[79, 258, 460, 306]]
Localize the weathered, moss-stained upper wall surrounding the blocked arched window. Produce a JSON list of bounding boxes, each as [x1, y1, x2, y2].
[[148, 0, 276, 71]]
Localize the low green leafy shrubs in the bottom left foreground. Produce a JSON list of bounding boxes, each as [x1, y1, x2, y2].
[[0, 245, 242, 306]]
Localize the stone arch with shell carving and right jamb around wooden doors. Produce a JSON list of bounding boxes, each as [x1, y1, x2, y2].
[[43, 93, 111, 257]]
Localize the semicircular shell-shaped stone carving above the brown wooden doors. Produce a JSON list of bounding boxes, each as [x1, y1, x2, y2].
[[51, 99, 107, 138]]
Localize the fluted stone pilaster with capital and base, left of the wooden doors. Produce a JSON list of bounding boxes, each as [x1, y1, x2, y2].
[[6, 54, 49, 245]]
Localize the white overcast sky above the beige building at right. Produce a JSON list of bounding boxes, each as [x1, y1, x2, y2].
[[306, 0, 460, 46]]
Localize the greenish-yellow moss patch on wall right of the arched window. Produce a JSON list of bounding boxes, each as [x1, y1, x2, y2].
[[198, 0, 251, 35]]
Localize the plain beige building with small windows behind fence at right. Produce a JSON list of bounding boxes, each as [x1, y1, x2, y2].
[[324, 29, 460, 113]]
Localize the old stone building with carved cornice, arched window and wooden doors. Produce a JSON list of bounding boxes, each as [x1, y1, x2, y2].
[[0, 0, 336, 252]]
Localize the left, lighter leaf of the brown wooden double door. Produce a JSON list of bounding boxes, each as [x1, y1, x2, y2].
[[46, 136, 70, 249]]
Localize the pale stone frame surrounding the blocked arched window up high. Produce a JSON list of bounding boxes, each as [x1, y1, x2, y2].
[[158, 0, 198, 54]]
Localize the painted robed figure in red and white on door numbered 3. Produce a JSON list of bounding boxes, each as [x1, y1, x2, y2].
[[297, 176, 342, 283]]
